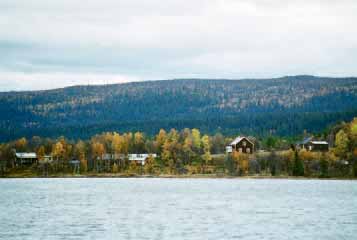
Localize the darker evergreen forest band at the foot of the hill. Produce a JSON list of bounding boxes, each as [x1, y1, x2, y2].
[[0, 110, 357, 141]]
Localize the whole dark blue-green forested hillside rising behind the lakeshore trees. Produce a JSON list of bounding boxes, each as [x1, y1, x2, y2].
[[0, 76, 357, 141]]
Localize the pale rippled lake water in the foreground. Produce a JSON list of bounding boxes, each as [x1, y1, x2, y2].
[[0, 178, 357, 240]]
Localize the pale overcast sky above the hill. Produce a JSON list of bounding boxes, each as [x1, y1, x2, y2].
[[0, 0, 357, 91]]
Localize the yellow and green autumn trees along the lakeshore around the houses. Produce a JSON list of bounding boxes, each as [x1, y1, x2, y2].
[[0, 119, 357, 177]]
